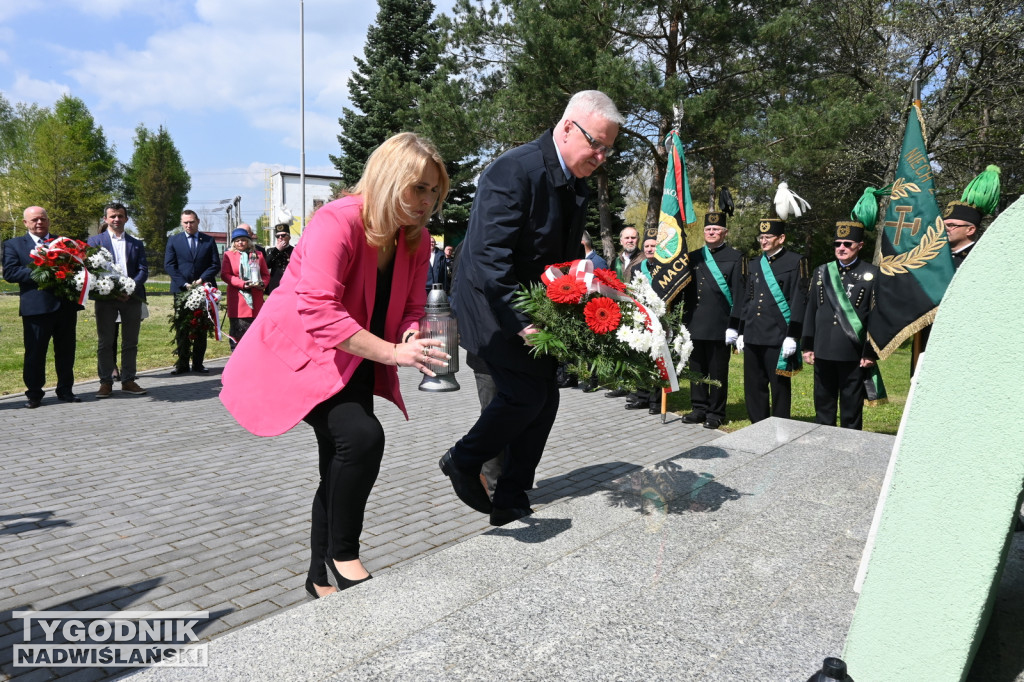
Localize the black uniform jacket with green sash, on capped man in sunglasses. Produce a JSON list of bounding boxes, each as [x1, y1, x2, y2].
[[804, 258, 879, 361]]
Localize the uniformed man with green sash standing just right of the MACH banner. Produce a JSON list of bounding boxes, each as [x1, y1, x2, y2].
[[682, 211, 746, 429]]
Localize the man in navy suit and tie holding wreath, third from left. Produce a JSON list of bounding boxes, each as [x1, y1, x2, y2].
[[164, 210, 220, 374]]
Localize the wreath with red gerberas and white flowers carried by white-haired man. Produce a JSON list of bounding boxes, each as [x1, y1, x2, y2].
[[515, 260, 715, 390]]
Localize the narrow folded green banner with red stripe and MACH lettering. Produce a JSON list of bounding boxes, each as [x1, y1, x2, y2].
[[644, 130, 697, 303]]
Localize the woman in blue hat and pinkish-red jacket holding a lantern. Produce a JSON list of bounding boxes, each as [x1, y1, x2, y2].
[[220, 227, 270, 350]]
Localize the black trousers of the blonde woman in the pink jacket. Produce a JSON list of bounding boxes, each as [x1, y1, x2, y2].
[[305, 360, 384, 585]]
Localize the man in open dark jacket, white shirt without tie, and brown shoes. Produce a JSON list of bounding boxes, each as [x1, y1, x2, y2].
[[89, 204, 150, 398]]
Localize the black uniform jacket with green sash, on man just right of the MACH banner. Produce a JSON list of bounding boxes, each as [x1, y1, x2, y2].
[[683, 244, 746, 343]]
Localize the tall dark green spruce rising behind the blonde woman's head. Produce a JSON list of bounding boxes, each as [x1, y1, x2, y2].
[[331, 0, 437, 186]]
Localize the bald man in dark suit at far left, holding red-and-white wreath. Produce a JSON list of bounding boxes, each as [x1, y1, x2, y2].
[[3, 206, 82, 409]]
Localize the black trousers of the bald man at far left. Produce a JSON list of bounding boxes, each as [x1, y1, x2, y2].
[[22, 302, 78, 400]]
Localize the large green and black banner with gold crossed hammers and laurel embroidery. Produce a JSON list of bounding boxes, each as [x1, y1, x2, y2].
[[867, 101, 953, 359]]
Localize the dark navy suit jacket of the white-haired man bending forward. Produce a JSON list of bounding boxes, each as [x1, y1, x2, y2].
[[452, 130, 588, 377]]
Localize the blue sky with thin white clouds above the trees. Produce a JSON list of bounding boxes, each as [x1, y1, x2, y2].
[[0, 0, 454, 229]]
